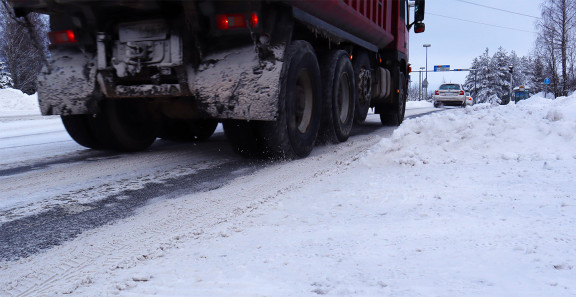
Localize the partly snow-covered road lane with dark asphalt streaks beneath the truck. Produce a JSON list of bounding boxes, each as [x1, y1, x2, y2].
[[0, 108, 435, 261]]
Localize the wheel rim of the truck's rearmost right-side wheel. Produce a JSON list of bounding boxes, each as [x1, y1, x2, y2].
[[294, 69, 314, 133]]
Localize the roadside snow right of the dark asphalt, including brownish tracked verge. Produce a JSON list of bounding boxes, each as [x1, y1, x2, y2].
[[0, 91, 576, 297]]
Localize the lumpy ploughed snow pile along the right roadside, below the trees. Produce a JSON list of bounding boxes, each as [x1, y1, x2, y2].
[[370, 97, 576, 166]]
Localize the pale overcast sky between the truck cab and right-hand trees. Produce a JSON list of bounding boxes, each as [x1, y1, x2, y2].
[[410, 0, 543, 91]]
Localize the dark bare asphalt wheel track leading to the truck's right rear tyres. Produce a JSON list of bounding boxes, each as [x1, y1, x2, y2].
[[0, 160, 258, 261]]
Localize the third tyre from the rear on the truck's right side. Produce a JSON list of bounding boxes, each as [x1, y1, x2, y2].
[[353, 51, 372, 124]]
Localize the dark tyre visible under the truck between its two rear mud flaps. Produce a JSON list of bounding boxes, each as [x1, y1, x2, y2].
[[159, 118, 218, 141]]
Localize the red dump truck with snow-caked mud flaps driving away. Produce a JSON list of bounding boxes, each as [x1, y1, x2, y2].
[[9, 0, 425, 158]]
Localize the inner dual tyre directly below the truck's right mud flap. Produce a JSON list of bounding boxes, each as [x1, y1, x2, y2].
[[222, 120, 262, 158]]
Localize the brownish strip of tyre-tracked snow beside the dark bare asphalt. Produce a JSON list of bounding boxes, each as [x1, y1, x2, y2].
[[0, 129, 392, 296]]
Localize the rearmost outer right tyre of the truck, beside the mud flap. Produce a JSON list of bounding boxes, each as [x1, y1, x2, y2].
[[258, 40, 322, 159]]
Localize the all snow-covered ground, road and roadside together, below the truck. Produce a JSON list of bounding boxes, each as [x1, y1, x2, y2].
[[0, 96, 576, 297]]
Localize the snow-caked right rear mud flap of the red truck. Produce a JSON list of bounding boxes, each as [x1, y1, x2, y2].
[[191, 46, 285, 121]]
